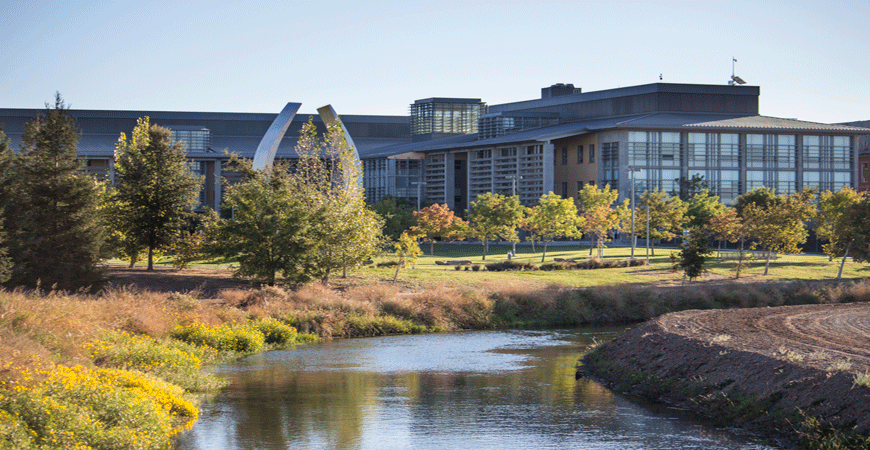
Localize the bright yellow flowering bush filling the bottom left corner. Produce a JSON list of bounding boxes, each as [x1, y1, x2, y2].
[[0, 366, 199, 450]]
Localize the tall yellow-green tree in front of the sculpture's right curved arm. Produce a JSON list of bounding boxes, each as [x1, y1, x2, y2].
[[291, 119, 383, 283]]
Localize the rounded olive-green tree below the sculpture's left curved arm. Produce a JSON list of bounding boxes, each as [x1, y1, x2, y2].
[[206, 158, 313, 285]]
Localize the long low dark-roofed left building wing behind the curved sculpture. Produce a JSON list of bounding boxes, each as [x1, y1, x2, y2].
[[0, 109, 411, 210]]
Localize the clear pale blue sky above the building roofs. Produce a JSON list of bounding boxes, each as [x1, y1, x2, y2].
[[0, 0, 870, 123]]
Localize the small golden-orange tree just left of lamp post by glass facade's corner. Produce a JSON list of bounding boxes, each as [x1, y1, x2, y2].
[[577, 184, 630, 258]]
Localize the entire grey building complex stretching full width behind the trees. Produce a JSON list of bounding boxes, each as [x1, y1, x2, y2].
[[0, 83, 870, 213]]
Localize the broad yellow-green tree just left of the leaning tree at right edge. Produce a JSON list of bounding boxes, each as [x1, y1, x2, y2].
[[743, 189, 816, 275]]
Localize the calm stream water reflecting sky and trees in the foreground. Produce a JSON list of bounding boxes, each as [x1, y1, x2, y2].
[[176, 328, 773, 450]]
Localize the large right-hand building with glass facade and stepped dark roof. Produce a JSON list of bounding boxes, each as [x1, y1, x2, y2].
[[362, 83, 870, 211]]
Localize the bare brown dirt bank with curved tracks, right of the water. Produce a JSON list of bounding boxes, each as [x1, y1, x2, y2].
[[578, 303, 870, 443]]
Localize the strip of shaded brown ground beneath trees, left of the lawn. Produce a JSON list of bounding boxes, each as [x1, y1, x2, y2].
[[106, 265, 251, 298]]
